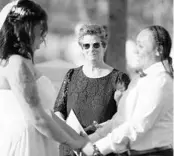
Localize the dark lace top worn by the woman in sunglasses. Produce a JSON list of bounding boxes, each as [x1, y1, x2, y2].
[[54, 66, 130, 128]]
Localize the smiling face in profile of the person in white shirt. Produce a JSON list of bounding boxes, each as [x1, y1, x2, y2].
[[133, 29, 160, 69]]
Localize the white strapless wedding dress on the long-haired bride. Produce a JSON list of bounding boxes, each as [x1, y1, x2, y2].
[[0, 76, 59, 156]]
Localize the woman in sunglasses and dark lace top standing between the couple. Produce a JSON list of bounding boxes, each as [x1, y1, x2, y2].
[[54, 24, 130, 156]]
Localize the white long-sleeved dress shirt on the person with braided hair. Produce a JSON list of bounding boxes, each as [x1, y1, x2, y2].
[[95, 62, 173, 154]]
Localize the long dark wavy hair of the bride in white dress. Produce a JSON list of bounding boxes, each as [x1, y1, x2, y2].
[[0, 0, 48, 61]]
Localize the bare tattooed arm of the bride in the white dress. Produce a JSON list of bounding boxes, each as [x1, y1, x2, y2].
[[6, 56, 86, 149]]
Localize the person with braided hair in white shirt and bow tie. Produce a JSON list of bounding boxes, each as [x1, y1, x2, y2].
[[81, 26, 173, 156]]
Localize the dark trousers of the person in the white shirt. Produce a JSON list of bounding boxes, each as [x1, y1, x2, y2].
[[119, 149, 173, 156]]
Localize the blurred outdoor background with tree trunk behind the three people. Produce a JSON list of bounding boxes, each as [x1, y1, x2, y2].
[[0, 0, 173, 90]]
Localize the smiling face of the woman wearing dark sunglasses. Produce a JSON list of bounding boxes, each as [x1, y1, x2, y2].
[[81, 35, 105, 61]]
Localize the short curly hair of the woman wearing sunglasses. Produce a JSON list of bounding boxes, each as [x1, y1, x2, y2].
[[78, 24, 109, 48]]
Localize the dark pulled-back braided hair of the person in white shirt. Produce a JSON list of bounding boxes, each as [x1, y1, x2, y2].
[[146, 25, 173, 77]]
